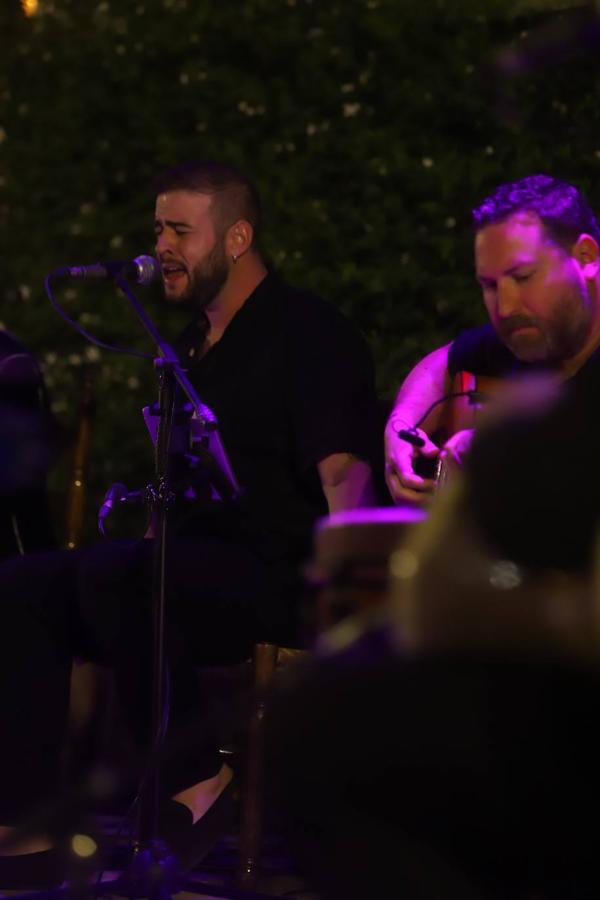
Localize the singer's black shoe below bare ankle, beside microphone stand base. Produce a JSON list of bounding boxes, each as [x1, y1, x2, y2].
[[159, 779, 237, 872]]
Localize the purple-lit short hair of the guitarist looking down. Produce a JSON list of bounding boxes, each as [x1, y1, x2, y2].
[[473, 175, 600, 250]]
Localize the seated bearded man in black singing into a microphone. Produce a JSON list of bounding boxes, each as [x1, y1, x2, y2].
[[0, 156, 377, 887]]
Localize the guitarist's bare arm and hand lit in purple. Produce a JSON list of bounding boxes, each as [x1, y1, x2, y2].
[[385, 344, 450, 502]]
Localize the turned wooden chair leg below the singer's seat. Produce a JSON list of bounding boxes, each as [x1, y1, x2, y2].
[[236, 643, 279, 888]]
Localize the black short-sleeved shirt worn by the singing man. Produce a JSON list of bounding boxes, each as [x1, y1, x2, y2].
[[171, 274, 378, 557]]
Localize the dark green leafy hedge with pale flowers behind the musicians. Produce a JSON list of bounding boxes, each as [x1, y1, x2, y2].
[[0, 0, 600, 536]]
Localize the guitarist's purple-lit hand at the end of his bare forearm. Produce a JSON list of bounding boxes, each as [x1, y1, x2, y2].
[[385, 419, 440, 503]]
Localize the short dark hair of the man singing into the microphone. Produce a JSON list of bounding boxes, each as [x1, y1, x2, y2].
[[153, 160, 261, 244]]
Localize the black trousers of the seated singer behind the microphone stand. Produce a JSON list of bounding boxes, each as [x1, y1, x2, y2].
[[0, 538, 300, 824]]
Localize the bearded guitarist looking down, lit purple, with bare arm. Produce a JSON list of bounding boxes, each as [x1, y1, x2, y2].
[[385, 175, 600, 502]]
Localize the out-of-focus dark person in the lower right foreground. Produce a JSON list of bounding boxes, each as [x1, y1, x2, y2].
[[267, 369, 600, 900]]
